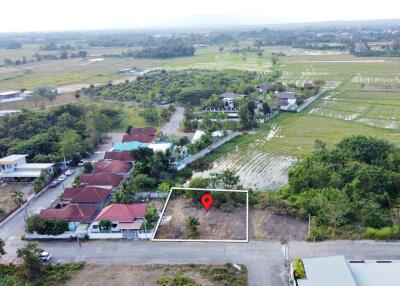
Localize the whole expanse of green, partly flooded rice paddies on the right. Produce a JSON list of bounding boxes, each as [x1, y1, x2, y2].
[[195, 50, 400, 190]]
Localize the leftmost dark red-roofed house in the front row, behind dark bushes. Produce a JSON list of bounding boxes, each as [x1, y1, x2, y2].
[[39, 204, 98, 230]]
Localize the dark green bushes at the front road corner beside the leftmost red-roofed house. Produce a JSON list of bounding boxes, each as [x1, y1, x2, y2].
[[26, 214, 68, 235]]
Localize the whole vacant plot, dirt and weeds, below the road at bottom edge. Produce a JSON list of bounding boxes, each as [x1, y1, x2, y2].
[[66, 264, 247, 286]]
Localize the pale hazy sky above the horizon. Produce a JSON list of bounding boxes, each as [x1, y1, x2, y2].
[[0, 0, 400, 32]]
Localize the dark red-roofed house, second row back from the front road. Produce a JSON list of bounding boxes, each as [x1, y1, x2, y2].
[[60, 187, 111, 207]]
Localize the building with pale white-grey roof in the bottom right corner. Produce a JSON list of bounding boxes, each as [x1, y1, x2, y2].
[[294, 256, 400, 286]]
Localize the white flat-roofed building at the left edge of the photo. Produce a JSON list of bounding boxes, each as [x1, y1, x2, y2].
[[0, 154, 54, 179]]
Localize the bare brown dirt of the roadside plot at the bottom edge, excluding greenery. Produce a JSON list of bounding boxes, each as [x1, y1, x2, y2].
[[66, 264, 247, 286]]
